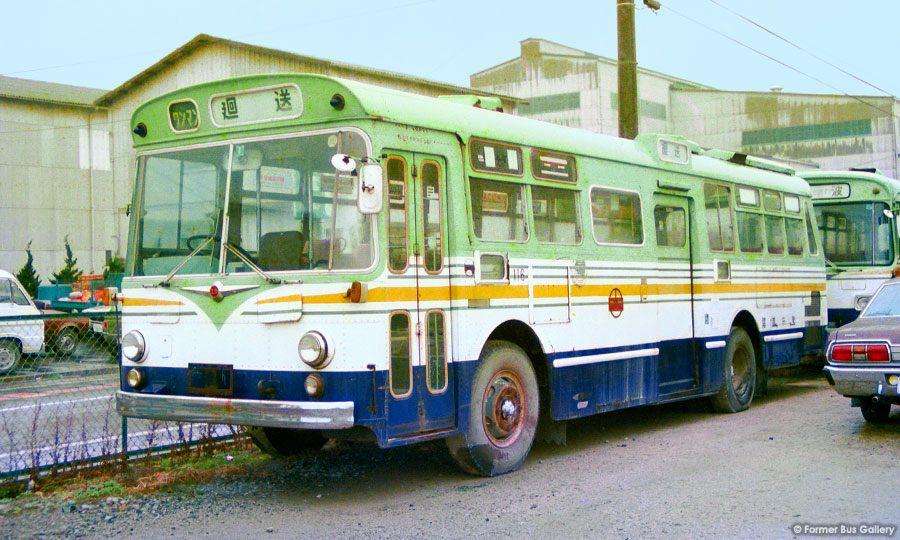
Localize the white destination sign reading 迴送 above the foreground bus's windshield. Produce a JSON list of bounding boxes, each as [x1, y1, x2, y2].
[[209, 84, 303, 127]]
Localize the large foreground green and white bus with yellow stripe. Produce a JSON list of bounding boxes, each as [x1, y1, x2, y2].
[[117, 74, 825, 475]]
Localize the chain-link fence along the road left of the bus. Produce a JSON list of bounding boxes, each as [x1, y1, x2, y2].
[[0, 308, 236, 481]]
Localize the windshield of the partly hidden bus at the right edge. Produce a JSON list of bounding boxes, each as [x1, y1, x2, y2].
[[815, 202, 894, 266]]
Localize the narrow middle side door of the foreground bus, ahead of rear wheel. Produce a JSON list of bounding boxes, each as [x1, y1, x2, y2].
[[653, 193, 699, 399]]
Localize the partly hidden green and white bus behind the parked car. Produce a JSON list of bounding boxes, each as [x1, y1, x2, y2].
[[799, 169, 900, 327]]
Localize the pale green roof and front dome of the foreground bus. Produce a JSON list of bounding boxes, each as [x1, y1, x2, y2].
[[132, 73, 810, 195]]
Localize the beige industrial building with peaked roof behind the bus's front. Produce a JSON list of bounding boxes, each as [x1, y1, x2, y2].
[[0, 34, 520, 283]]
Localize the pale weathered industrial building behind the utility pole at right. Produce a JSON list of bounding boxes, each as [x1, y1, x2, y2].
[[470, 38, 900, 178]]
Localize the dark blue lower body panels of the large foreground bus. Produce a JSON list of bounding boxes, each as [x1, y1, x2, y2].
[[120, 330, 820, 447]]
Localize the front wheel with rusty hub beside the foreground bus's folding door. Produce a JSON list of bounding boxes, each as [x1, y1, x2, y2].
[[447, 341, 540, 476]]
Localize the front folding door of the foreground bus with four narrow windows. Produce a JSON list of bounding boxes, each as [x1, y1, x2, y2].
[[385, 152, 456, 439]]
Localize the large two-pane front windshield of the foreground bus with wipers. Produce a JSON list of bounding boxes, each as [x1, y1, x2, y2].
[[134, 132, 374, 276]]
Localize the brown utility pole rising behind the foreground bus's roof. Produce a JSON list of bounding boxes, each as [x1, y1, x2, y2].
[[616, 0, 638, 139]]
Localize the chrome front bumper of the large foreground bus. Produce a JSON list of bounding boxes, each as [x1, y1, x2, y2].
[[116, 390, 353, 429]]
